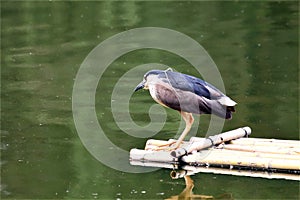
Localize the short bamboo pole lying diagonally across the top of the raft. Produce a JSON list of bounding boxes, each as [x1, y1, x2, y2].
[[171, 127, 251, 158]]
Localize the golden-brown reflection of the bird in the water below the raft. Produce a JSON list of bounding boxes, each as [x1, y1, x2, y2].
[[166, 175, 233, 200]]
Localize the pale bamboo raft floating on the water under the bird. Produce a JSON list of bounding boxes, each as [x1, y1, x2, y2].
[[130, 127, 300, 180]]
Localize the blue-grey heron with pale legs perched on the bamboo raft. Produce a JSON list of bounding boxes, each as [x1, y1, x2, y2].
[[134, 68, 237, 150]]
